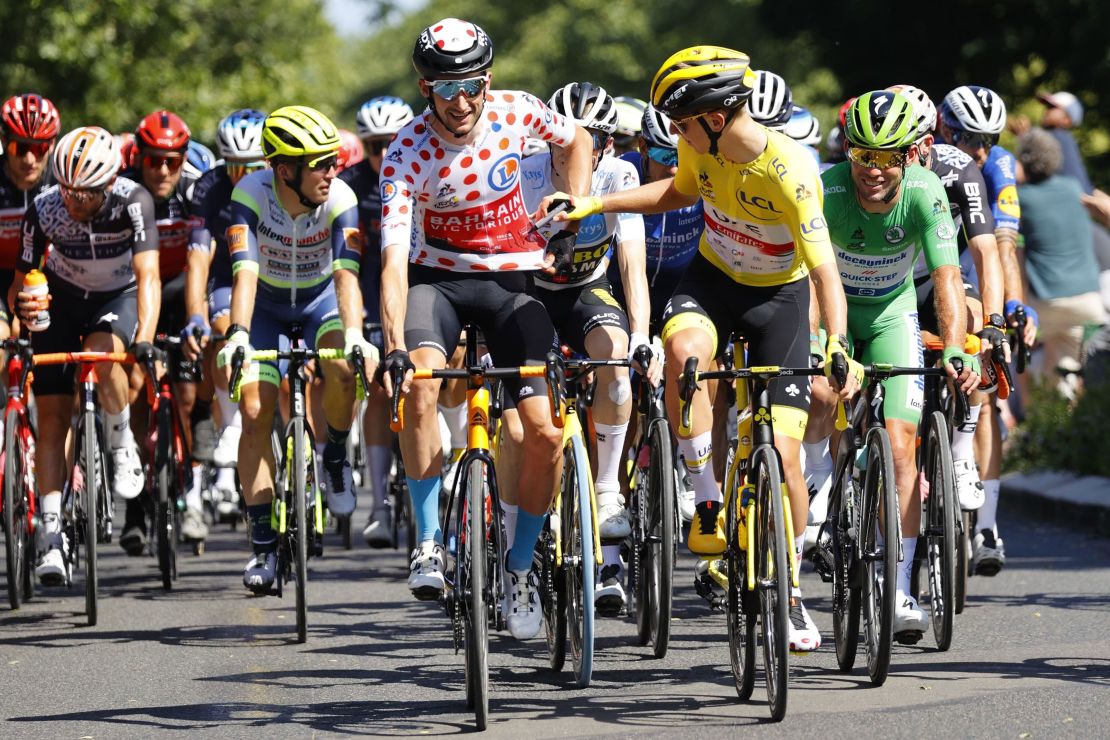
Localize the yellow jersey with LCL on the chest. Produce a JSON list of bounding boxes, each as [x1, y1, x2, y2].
[[675, 129, 835, 287]]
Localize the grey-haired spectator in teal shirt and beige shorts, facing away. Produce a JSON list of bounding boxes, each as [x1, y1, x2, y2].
[[1018, 129, 1106, 397]]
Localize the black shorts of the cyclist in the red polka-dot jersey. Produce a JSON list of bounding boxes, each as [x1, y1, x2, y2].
[[405, 265, 558, 399]]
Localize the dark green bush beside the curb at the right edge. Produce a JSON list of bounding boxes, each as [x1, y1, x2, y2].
[[1002, 384, 1110, 477]]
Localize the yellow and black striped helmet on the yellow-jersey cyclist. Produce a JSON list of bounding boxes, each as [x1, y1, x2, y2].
[[652, 47, 756, 119]]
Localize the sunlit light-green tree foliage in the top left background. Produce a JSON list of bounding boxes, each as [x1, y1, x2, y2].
[[0, 0, 359, 141]]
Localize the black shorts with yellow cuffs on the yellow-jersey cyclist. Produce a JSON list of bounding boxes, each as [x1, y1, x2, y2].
[[664, 254, 809, 438]]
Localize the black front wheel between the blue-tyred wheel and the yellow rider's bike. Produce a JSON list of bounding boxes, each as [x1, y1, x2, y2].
[[644, 418, 677, 658]]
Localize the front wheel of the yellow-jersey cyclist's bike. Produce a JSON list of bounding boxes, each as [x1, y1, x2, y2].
[[753, 447, 794, 722]]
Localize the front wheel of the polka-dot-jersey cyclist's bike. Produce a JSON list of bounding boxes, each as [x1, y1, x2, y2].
[[463, 459, 490, 731]]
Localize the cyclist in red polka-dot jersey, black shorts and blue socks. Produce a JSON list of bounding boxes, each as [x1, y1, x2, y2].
[[381, 18, 593, 639]]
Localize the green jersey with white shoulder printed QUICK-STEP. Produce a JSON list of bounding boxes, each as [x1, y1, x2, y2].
[[821, 162, 959, 305]]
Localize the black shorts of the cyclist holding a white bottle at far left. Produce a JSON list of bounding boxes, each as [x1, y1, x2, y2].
[[31, 280, 139, 396]]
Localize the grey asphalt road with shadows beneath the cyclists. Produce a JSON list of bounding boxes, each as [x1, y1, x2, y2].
[[0, 497, 1110, 740]]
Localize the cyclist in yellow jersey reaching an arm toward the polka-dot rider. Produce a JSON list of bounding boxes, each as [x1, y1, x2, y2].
[[542, 47, 862, 650]]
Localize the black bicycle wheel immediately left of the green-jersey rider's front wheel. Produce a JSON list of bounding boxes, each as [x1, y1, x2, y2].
[[829, 465, 862, 673]]
